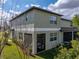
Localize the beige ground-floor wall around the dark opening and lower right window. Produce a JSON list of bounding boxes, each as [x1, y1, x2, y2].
[[32, 31, 63, 54]]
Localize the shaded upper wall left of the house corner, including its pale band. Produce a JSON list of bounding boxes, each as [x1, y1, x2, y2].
[[10, 11, 34, 36]]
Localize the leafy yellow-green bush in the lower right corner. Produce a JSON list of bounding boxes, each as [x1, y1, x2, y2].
[[54, 40, 79, 59]]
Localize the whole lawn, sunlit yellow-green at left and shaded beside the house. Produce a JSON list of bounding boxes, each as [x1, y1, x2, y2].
[[1, 43, 58, 59]]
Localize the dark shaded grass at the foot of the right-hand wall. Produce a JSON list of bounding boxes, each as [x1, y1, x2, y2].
[[37, 47, 59, 59]]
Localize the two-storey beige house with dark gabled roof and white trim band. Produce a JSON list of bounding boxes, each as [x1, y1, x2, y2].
[[10, 7, 76, 54]]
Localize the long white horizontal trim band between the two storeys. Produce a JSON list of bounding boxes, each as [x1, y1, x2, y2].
[[15, 28, 61, 31]]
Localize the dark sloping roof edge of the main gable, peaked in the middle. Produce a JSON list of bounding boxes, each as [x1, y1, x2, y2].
[[10, 6, 62, 21]]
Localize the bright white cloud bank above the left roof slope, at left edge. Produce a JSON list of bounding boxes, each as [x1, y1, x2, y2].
[[0, 10, 21, 23]]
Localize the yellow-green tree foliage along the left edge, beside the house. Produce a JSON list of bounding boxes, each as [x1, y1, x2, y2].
[[0, 23, 11, 56]]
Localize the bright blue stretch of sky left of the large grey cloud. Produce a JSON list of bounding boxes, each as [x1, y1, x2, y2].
[[0, 0, 57, 11]]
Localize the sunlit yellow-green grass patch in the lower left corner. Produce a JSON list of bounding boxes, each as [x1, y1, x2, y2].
[[1, 43, 23, 59]]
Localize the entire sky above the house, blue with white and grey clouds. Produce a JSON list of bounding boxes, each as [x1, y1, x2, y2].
[[0, 0, 79, 20]]
